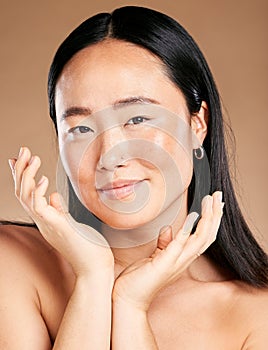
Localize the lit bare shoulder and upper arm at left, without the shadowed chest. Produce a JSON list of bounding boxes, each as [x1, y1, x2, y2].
[[0, 225, 59, 350]]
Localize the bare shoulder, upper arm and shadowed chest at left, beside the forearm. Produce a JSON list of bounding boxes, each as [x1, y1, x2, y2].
[[0, 225, 72, 350]]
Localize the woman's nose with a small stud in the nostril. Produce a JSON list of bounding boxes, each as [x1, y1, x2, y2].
[[97, 126, 129, 171]]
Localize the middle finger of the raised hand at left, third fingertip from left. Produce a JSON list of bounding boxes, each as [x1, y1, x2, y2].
[[20, 156, 41, 207]]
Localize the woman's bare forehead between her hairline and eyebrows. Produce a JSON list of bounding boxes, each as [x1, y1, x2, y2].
[[55, 39, 188, 116]]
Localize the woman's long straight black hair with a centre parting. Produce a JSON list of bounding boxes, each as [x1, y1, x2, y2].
[[48, 6, 268, 287]]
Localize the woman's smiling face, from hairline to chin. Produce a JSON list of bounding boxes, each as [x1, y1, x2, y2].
[[55, 40, 205, 229]]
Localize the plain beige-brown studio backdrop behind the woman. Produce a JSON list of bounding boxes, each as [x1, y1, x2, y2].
[[0, 0, 268, 248]]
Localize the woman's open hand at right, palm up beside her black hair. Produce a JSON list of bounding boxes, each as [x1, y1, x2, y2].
[[113, 192, 224, 311]]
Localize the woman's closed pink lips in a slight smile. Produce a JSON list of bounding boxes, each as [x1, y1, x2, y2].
[[97, 180, 145, 200]]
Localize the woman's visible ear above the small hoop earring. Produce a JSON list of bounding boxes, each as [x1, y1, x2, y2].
[[191, 101, 208, 145]]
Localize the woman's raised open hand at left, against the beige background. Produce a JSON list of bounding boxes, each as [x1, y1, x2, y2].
[[9, 147, 114, 277]]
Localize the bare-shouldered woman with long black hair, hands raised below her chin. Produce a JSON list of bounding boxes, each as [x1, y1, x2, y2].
[[0, 6, 268, 350]]
